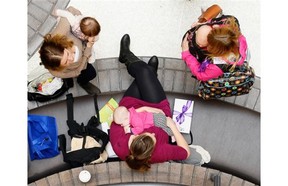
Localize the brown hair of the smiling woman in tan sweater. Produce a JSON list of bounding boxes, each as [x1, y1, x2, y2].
[[39, 34, 73, 70]]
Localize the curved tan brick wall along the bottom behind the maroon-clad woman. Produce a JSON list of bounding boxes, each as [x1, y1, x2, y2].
[[29, 161, 255, 186]]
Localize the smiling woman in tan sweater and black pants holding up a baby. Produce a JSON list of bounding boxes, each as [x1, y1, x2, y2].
[[39, 6, 100, 94]]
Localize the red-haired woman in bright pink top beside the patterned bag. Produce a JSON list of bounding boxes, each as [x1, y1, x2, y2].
[[182, 15, 247, 81]]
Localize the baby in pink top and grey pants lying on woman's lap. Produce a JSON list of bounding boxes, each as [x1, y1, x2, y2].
[[113, 106, 173, 136]]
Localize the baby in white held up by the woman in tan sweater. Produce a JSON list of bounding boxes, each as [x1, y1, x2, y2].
[[52, 6, 101, 63]]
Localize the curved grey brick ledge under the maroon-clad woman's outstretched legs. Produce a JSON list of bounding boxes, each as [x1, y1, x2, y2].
[[28, 57, 261, 112]]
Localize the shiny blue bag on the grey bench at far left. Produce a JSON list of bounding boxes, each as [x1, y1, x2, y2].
[[28, 114, 59, 161]]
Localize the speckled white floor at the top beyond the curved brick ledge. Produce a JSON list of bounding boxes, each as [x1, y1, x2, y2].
[[28, 0, 261, 77]]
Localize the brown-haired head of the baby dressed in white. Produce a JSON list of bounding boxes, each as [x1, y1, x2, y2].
[[80, 17, 101, 37]]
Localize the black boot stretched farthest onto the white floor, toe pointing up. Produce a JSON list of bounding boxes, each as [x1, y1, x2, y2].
[[119, 34, 141, 67]]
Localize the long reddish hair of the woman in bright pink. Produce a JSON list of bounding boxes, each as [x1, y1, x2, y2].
[[207, 17, 241, 58]]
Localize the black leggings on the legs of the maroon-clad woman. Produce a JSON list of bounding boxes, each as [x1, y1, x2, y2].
[[123, 61, 166, 103]]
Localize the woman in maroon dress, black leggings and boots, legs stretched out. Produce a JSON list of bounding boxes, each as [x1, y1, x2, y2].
[[110, 34, 190, 171]]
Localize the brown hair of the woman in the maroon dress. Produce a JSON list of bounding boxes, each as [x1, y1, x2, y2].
[[126, 134, 155, 172]]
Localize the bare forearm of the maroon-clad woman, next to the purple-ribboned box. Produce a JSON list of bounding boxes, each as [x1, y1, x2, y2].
[[167, 117, 190, 158]]
